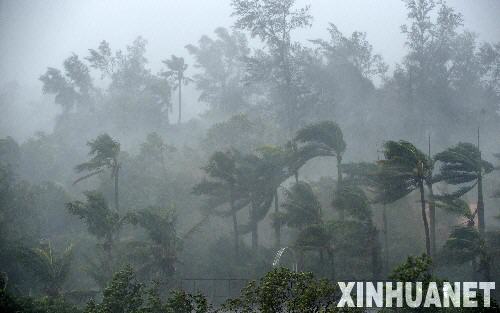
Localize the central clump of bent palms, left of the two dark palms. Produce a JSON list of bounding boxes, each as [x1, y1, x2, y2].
[[193, 121, 346, 264]]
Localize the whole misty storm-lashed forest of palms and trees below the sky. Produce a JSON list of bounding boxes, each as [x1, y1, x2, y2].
[[0, 0, 500, 313]]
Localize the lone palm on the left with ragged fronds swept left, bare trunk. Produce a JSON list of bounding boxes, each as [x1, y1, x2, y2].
[[73, 134, 120, 211]]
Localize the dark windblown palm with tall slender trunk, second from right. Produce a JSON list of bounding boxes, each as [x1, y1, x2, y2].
[[379, 140, 431, 256]]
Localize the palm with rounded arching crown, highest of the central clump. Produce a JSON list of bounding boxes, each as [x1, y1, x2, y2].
[[294, 121, 346, 219]]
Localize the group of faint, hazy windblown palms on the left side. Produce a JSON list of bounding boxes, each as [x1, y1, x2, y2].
[[66, 134, 179, 286]]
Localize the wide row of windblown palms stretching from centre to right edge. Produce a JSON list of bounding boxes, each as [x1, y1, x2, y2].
[[194, 121, 494, 276]]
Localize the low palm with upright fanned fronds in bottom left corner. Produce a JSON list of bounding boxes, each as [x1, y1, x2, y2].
[[19, 241, 73, 297]]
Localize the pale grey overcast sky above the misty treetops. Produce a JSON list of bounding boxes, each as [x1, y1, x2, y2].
[[0, 0, 500, 88]]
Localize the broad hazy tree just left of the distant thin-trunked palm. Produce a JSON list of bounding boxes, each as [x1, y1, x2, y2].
[[85, 37, 172, 127]]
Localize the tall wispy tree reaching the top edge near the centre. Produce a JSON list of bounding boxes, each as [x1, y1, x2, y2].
[[231, 0, 312, 134]]
